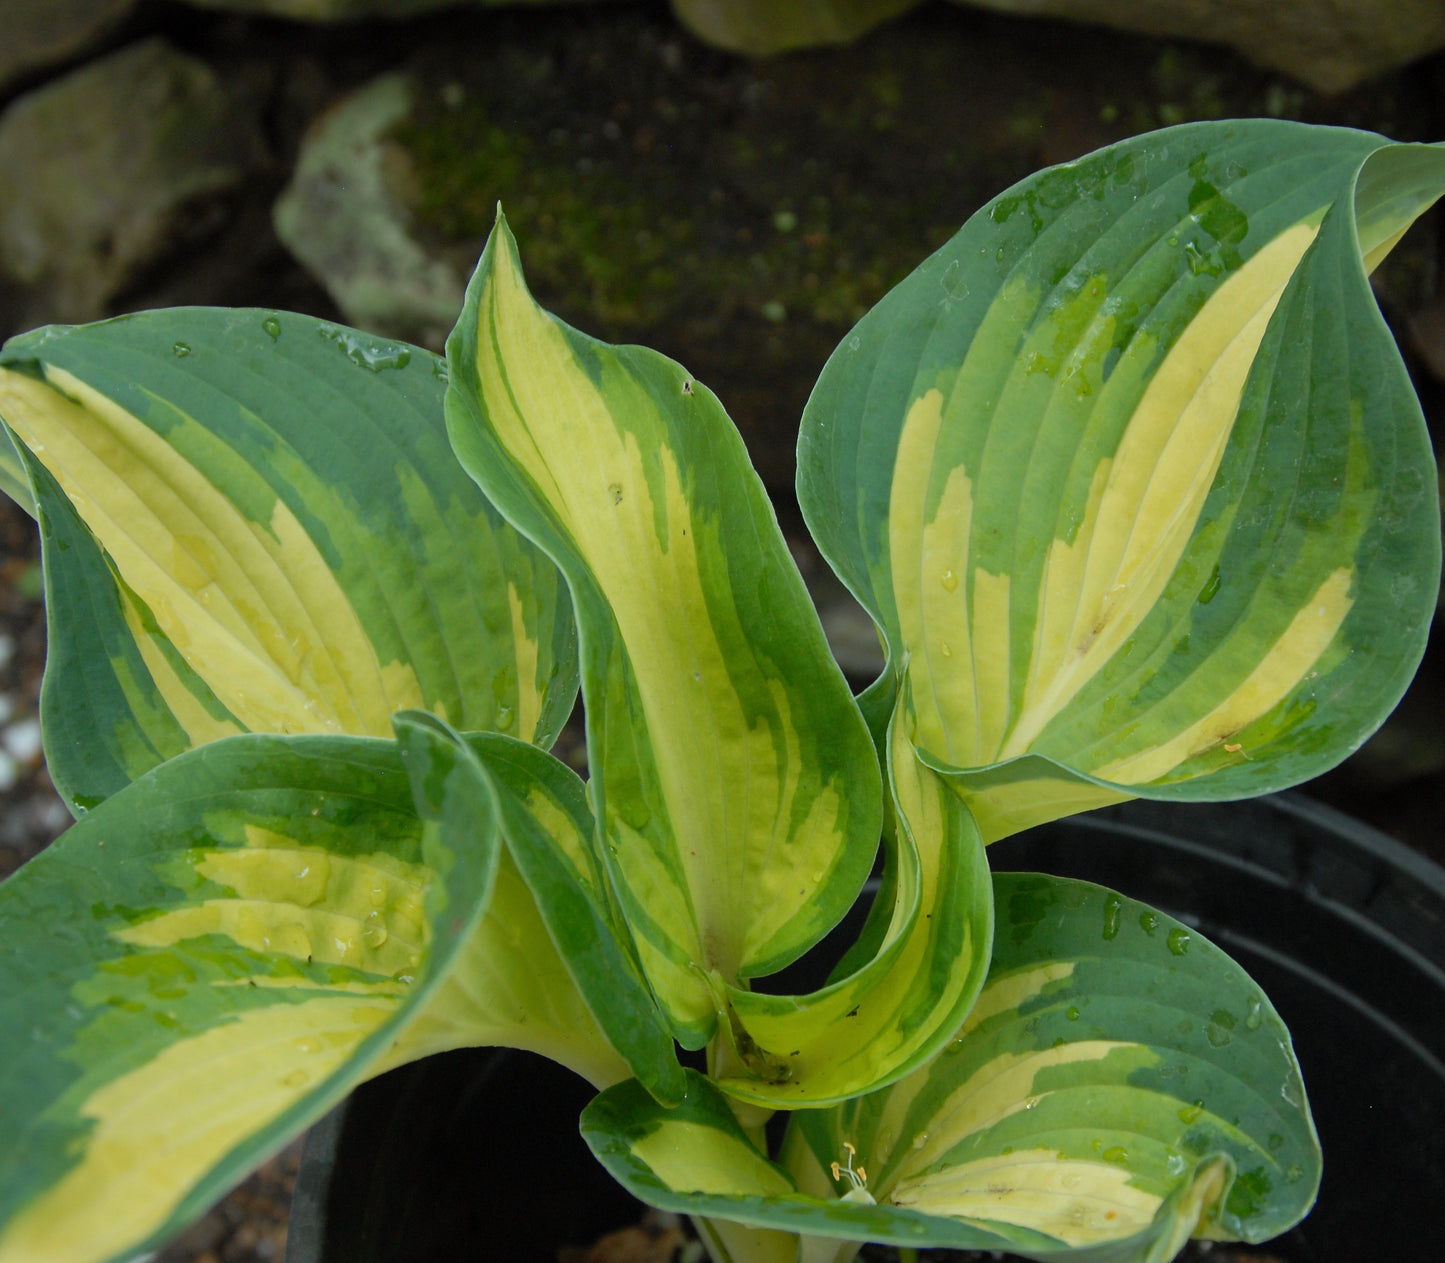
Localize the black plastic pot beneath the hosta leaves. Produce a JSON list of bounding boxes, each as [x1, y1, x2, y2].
[[286, 796, 1445, 1263]]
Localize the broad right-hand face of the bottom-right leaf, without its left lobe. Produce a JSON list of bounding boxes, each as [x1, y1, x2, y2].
[[788, 873, 1321, 1257]]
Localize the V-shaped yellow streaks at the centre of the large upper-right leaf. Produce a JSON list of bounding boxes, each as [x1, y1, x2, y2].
[[890, 212, 1323, 780]]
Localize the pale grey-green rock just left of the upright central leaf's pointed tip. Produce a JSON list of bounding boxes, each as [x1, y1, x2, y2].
[[275, 75, 464, 348]]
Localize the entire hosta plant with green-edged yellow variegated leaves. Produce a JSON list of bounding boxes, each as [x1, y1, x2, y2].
[[0, 121, 1445, 1263]]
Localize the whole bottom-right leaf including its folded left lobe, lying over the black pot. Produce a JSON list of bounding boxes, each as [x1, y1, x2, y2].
[[582, 873, 1319, 1263]]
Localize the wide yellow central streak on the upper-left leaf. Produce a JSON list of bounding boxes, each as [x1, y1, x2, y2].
[[0, 361, 422, 736]]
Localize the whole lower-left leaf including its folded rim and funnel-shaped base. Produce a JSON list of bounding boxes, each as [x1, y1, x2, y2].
[[0, 715, 664, 1263]]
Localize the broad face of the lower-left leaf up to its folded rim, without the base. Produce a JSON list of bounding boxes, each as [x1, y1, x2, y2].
[[0, 734, 502, 1263]]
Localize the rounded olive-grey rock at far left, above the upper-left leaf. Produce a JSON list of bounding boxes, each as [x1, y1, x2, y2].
[[0, 39, 264, 321]]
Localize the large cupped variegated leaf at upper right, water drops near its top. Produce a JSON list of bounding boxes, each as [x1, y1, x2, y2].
[[799, 120, 1445, 840]]
